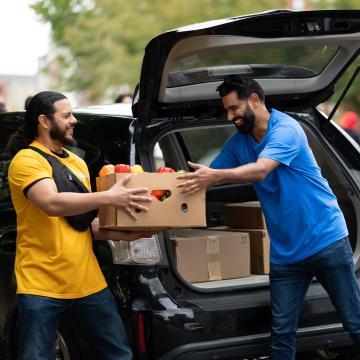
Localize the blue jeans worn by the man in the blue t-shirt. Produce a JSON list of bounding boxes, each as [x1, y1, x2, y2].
[[270, 237, 360, 360]]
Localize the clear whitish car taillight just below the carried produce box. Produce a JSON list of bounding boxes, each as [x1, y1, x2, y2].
[[108, 235, 160, 265]]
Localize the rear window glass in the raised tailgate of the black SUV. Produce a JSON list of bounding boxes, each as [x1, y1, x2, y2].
[[167, 44, 338, 87]]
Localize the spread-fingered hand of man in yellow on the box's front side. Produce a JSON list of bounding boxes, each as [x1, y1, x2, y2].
[[108, 175, 152, 220]]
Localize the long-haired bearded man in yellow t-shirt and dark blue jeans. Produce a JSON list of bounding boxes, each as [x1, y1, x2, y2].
[[8, 91, 151, 360]]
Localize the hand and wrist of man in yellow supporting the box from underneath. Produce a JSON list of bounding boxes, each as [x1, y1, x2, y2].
[[91, 218, 158, 241]]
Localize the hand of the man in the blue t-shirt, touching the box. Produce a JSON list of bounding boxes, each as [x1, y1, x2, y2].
[[177, 161, 219, 195]]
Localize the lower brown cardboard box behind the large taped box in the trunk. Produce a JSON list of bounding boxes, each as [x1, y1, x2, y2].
[[211, 226, 270, 274]]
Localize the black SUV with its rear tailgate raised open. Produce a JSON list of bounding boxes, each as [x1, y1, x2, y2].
[[0, 11, 360, 360]]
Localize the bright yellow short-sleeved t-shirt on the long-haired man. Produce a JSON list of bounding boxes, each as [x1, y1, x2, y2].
[[9, 141, 107, 299]]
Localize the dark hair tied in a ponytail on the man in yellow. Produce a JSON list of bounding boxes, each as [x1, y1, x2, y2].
[[6, 91, 66, 156]]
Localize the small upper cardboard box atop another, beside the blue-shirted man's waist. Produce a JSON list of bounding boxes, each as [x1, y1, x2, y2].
[[224, 201, 266, 229]]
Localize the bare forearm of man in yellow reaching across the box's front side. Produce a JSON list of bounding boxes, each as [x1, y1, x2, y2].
[[45, 191, 110, 216]]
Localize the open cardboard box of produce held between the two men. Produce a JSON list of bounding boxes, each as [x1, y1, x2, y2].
[[96, 173, 206, 230]]
